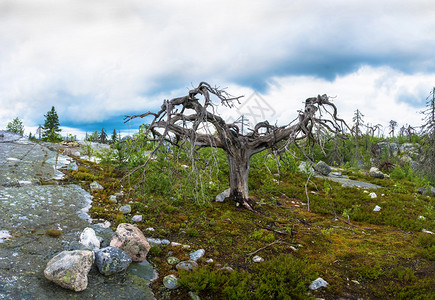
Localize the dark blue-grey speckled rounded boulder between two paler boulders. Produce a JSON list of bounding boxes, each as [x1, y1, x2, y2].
[[95, 246, 131, 276]]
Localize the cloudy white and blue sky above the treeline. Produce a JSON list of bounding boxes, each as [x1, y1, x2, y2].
[[0, 0, 435, 135]]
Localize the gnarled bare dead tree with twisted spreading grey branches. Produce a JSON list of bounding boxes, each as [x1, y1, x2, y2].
[[125, 82, 346, 210]]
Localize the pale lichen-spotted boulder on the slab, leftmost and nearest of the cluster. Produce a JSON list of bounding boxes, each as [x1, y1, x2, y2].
[[44, 250, 94, 292]]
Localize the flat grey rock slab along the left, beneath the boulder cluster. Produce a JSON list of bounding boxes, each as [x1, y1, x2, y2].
[[0, 135, 154, 300]]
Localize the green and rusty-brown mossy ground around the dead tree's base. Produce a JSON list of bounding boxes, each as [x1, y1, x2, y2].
[[59, 145, 435, 299]]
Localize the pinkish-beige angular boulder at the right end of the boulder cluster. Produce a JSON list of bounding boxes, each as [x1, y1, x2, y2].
[[110, 223, 151, 261]]
